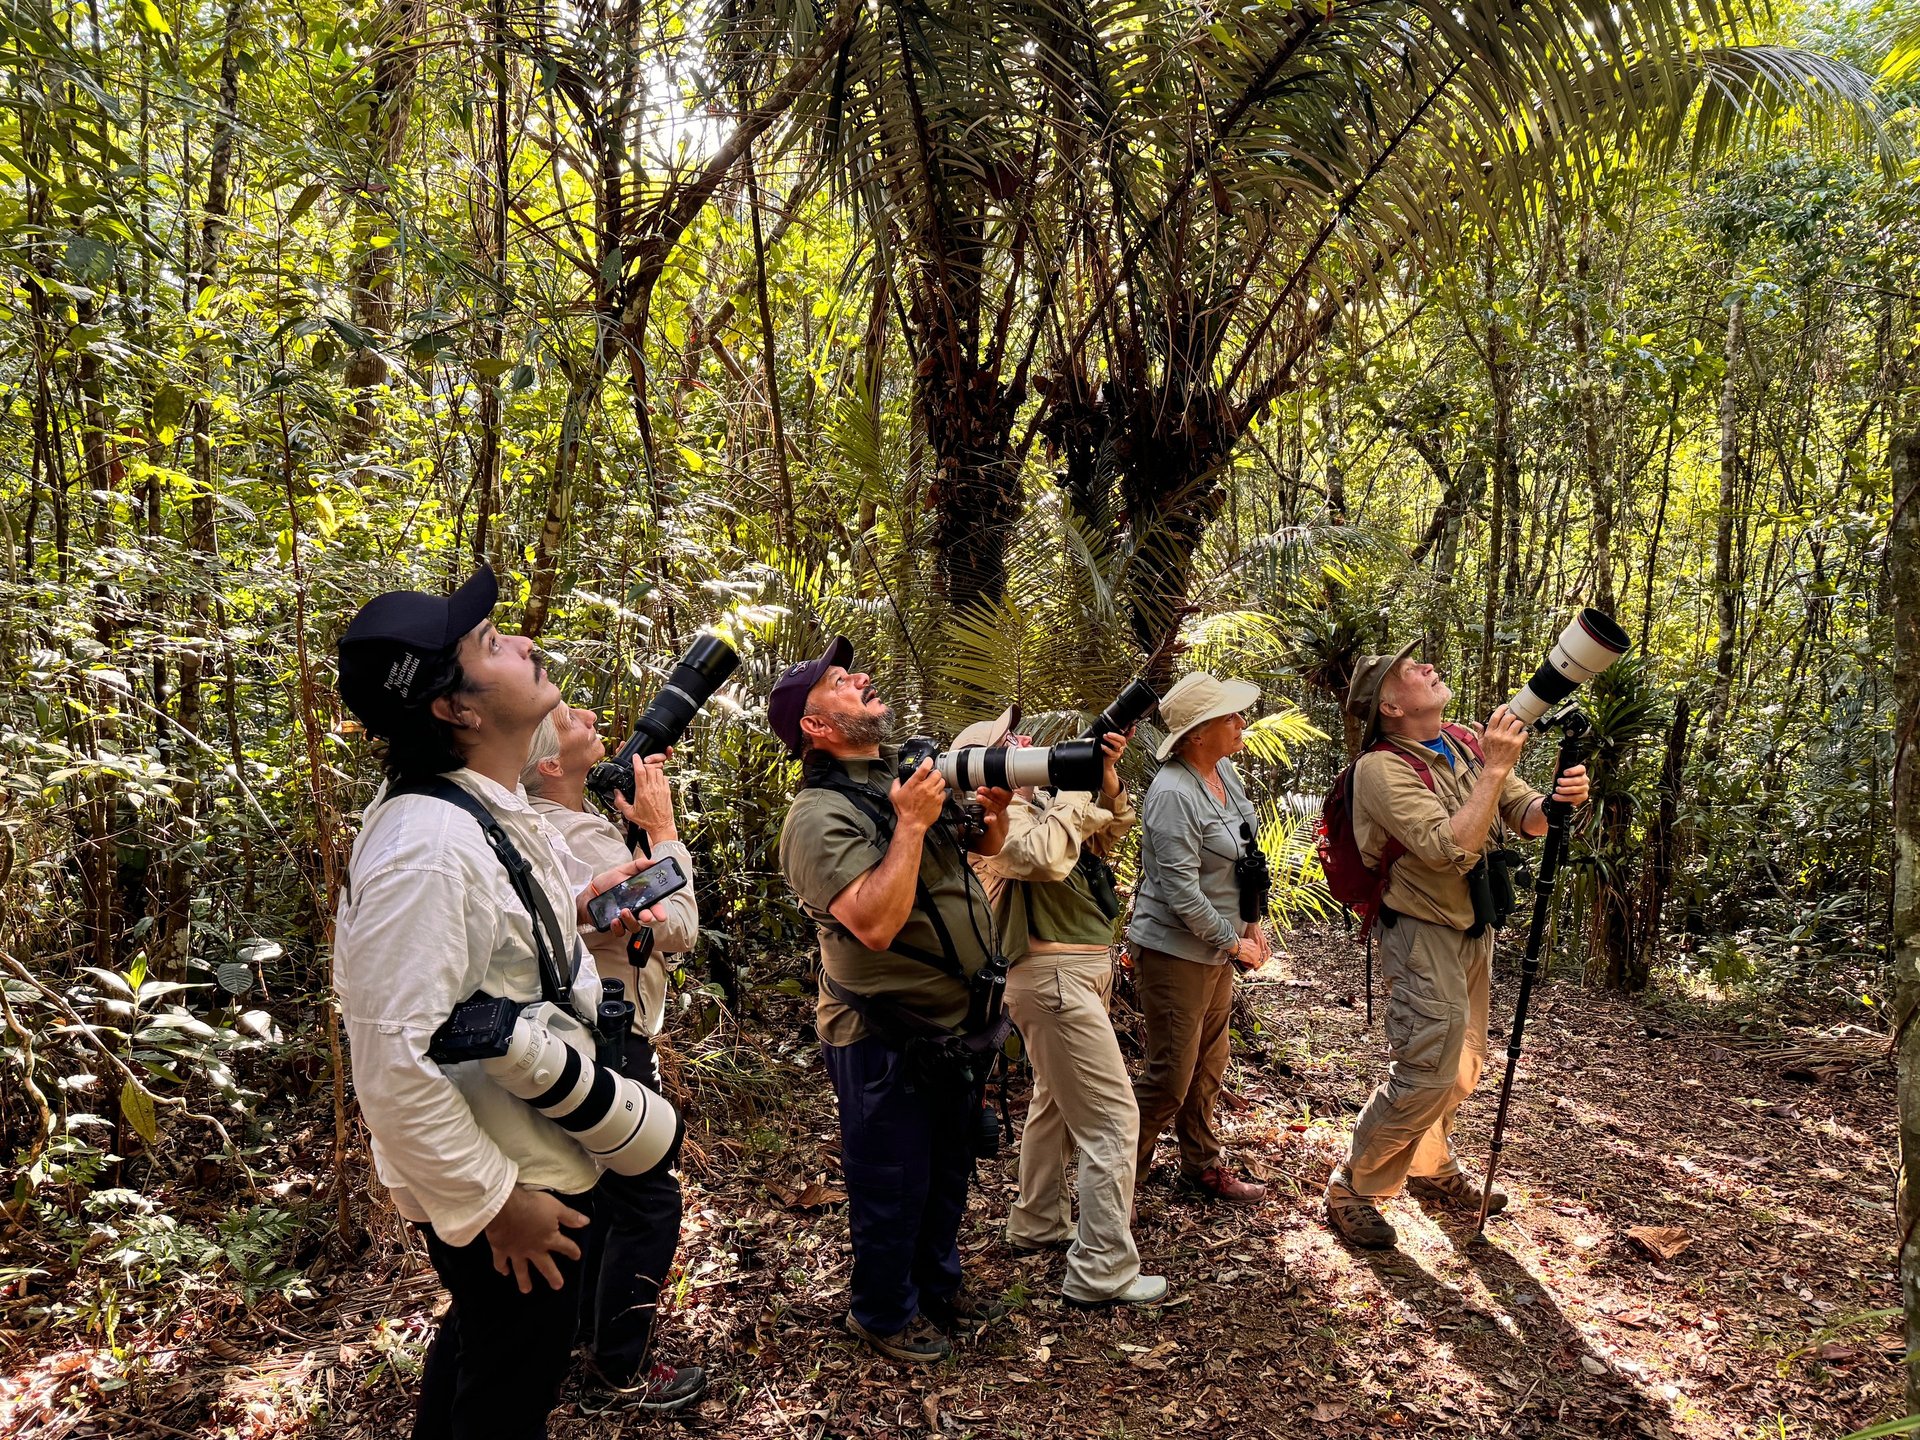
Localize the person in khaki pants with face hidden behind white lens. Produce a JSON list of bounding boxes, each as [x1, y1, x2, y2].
[[954, 707, 1167, 1306]]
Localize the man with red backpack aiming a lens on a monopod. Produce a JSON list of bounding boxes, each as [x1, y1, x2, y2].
[[1327, 645, 1586, 1250]]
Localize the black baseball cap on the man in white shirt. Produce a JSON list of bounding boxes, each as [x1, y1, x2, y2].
[[340, 564, 499, 737]]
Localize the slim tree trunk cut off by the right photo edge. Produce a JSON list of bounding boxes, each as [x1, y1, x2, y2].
[[1887, 415, 1920, 1413]]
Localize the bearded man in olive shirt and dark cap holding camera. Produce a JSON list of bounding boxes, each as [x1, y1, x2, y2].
[[768, 636, 1012, 1365]]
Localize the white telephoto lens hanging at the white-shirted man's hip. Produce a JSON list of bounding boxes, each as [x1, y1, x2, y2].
[[480, 1002, 680, 1175]]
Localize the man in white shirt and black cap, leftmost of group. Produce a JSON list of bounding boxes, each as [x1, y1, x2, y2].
[[334, 568, 705, 1440]]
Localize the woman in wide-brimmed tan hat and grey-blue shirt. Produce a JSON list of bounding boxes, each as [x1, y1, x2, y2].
[[1127, 670, 1267, 1206]]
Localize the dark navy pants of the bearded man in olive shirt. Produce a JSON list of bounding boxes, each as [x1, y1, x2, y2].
[[820, 1035, 973, 1334]]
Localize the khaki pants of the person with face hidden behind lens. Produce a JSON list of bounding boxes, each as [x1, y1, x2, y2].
[[1006, 950, 1140, 1300]]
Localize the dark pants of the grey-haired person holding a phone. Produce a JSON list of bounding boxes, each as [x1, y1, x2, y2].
[[582, 1031, 682, 1384]]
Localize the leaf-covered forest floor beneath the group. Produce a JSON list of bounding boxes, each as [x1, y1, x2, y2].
[[0, 933, 1903, 1440]]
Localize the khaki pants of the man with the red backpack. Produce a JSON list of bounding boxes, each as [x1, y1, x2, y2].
[[1327, 916, 1494, 1200]]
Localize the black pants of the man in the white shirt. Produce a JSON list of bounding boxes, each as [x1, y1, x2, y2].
[[413, 1194, 593, 1440]]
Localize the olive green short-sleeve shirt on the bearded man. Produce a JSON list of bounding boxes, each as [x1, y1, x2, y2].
[[780, 745, 993, 1044]]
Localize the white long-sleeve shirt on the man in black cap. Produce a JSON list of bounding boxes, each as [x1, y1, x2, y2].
[[334, 770, 599, 1244]]
